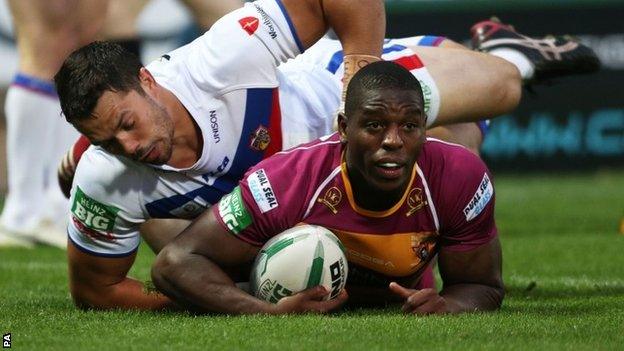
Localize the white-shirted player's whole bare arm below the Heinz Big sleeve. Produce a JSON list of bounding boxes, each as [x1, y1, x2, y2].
[[67, 242, 175, 310]]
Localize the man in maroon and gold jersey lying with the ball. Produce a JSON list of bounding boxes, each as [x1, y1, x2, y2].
[[152, 62, 504, 314]]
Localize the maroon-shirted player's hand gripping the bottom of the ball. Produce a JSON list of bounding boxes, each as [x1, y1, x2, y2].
[[275, 285, 349, 314]]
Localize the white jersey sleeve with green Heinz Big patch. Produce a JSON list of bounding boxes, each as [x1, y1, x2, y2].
[[67, 146, 145, 257]]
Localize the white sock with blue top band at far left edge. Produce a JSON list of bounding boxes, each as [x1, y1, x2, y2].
[[0, 74, 61, 232]]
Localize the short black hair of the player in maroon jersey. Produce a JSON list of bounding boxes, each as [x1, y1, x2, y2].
[[345, 61, 425, 117]]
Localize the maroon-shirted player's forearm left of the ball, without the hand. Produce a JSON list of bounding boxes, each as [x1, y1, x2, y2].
[[152, 252, 275, 314]]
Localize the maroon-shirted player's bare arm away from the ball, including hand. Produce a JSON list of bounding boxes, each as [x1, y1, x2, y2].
[[390, 237, 505, 315]]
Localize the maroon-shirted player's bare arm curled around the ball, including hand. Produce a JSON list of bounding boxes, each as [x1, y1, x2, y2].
[[152, 210, 346, 314]]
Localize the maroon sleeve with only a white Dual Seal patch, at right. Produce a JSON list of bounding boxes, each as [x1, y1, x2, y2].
[[434, 146, 497, 251]]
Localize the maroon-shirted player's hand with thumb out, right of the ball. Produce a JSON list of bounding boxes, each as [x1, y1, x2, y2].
[[389, 282, 450, 315]]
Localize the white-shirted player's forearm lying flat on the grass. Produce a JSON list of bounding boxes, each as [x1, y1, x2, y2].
[[71, 278, 175, 310]]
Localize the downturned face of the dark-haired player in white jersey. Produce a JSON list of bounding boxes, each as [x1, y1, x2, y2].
[[76, 90, 174, 164]]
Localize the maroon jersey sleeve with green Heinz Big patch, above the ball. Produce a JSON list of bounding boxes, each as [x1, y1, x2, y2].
[[212, 155, 310, 246]]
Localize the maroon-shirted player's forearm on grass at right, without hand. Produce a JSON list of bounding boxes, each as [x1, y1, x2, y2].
[[440, 284, 505, 313]]
